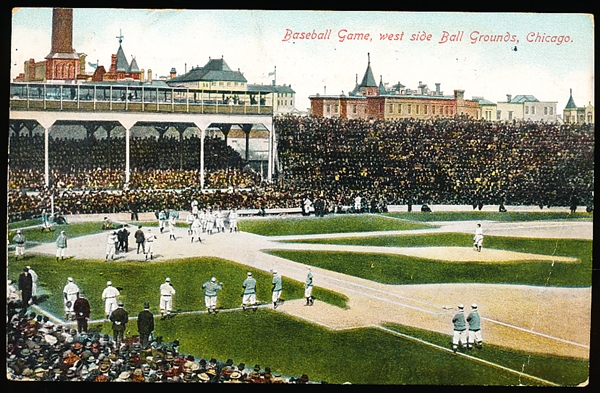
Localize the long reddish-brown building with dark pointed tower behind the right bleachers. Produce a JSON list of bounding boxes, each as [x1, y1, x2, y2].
[[309, 55, 478, 120]]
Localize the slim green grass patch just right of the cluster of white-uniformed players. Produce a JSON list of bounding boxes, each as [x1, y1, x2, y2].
[[238, 214, 435, 236]]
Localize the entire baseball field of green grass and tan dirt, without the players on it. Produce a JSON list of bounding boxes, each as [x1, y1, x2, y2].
[[8, 208, 593, 386]]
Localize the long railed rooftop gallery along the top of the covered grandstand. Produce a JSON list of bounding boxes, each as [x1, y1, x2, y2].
[[10, 82, 273, 115]]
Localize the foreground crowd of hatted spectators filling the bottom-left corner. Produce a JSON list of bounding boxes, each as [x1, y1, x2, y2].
[[6, 307, 324, 384]]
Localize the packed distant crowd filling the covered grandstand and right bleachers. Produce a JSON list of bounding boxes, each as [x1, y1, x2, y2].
[[9, 116, 595, 220]]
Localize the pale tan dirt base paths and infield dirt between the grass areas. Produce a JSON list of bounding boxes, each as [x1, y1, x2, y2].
[[29, 222, 593, 359]]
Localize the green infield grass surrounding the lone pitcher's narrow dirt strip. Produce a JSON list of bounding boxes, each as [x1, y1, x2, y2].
[[269, 233, 592, 287]]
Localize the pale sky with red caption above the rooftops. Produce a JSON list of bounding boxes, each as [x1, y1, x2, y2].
[[10, 8, 595, 113]]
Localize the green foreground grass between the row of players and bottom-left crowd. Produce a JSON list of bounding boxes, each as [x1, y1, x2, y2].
[[71, 309, 589, 386]]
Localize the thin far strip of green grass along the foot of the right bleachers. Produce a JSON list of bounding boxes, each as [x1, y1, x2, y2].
[[384, 208, 594, 222]]
